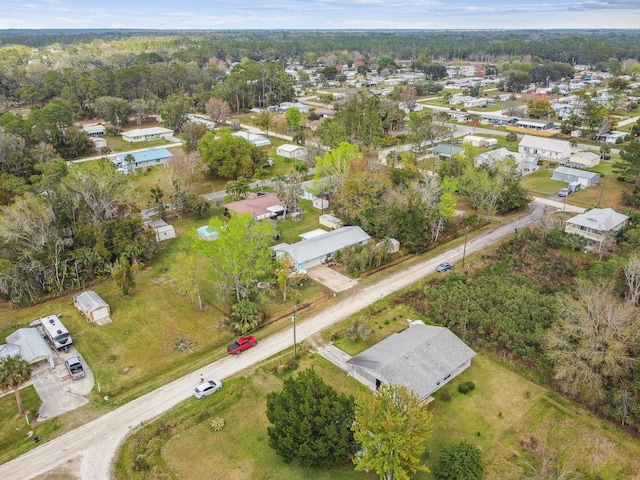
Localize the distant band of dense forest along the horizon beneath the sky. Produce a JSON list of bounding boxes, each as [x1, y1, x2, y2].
[[0, 30, 640, 65]]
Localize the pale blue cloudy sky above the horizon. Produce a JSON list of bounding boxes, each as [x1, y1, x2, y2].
[[0, 0, 640, 30]]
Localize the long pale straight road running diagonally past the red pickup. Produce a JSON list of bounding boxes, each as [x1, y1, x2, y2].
[[0, 201, 543, 480]]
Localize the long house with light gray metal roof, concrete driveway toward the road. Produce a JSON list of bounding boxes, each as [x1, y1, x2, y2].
[[272, 227, 371, 270]]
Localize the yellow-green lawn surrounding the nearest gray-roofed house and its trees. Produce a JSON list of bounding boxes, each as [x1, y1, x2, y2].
[[117, 344, 640, 480]]
